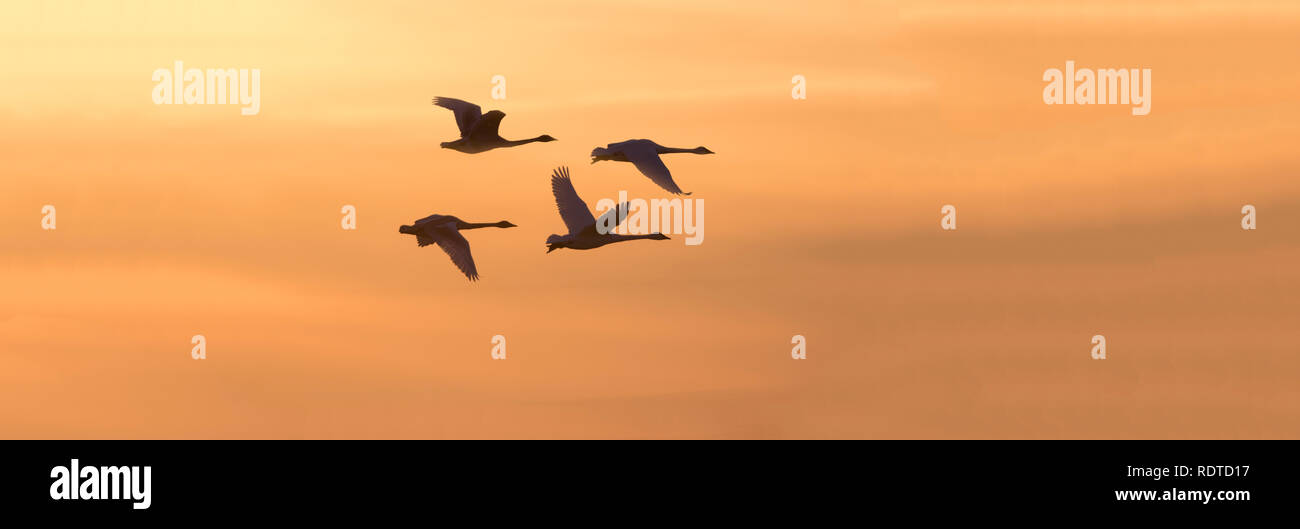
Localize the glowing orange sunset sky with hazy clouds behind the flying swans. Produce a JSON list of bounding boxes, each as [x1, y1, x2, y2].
[[0, 0, 1300, 438]]
